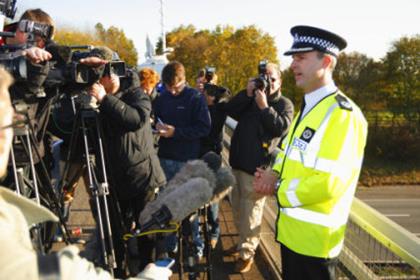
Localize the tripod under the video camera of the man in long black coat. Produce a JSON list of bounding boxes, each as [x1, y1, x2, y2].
[[62, 104, 117, 274]]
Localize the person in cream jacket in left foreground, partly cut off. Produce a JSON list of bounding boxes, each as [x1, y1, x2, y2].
[[0, 68, 171, 280]]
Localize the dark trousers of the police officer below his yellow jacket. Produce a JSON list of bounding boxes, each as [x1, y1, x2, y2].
[[280, 244, 338, 280]]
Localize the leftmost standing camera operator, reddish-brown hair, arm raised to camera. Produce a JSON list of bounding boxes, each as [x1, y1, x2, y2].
[[2, 9, 54, 192]]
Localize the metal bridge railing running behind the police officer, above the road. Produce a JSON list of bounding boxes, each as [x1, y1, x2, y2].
[[224, 118, 420, 280]]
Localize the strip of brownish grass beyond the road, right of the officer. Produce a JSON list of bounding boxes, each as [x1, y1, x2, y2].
[[359, 159, 420, 187]]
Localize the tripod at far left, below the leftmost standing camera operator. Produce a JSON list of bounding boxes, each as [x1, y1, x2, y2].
[[11, 122, 69, 253]]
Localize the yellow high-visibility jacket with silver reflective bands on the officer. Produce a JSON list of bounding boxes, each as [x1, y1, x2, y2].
[[273, 92, 367, 258]]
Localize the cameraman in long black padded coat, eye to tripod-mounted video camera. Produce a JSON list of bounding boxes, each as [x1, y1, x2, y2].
[[89, 47, 166, 270]]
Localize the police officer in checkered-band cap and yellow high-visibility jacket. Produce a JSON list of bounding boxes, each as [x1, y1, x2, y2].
[[254, 26, 367, 279]]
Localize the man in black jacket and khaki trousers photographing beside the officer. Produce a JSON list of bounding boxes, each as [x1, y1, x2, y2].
[[225, 63, 293, 273]]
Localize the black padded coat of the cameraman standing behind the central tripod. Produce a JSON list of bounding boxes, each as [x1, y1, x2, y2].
[[99, 84, 166, 200]]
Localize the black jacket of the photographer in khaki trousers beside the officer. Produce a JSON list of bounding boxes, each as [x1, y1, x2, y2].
[[225, 90, 293, 175]]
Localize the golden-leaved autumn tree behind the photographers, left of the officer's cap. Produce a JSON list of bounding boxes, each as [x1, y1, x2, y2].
[[158, 25, 278, 93]]
